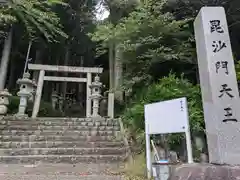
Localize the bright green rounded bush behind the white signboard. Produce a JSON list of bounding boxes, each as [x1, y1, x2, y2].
[[122, 74, 204, 144]]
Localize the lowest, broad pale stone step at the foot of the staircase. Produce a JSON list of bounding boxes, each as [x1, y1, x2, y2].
[[0, 162, 125, 176]]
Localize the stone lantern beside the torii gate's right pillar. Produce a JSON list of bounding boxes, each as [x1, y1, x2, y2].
[[90, 75, 102, 117]]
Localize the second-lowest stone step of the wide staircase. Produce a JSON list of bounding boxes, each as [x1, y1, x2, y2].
[[0, 148, 126, 156]]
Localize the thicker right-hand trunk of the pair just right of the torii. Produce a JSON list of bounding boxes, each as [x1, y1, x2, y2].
[[114, 44, 123, 101]]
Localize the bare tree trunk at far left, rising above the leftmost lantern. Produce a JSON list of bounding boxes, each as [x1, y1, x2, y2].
[[0, 29, 13, 91]]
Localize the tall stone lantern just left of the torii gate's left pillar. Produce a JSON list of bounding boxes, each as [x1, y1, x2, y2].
[[16, 73, 34, 117]]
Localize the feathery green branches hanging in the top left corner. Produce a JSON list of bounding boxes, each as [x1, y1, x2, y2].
[[0, 0, 67, 41]]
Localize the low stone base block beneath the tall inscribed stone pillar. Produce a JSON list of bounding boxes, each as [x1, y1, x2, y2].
[[169, 164, 240, 180]]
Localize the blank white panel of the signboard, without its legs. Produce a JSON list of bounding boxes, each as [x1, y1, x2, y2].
[[145, 98, 188, 134]]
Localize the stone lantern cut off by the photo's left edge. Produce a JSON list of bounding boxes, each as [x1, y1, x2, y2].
[[0, 89, 12, 116]]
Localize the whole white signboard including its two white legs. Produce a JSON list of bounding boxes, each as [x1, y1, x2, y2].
[[144, 98, 193, 179]]
